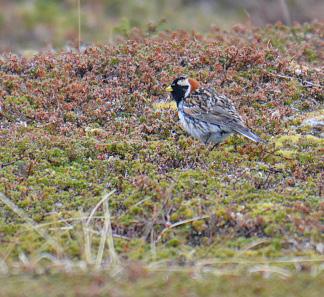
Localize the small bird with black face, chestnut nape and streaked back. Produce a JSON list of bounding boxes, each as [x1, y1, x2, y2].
[[166, 76, 265, 145]]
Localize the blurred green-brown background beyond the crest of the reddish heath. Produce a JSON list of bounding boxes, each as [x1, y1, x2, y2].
[[0, 0, 324, 51]]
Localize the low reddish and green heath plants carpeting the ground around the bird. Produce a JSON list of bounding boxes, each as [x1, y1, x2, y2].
[[0, 22, 324, 296]]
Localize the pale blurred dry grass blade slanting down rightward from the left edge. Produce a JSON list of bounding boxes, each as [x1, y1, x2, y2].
[[0, 192, 63, 255]]
